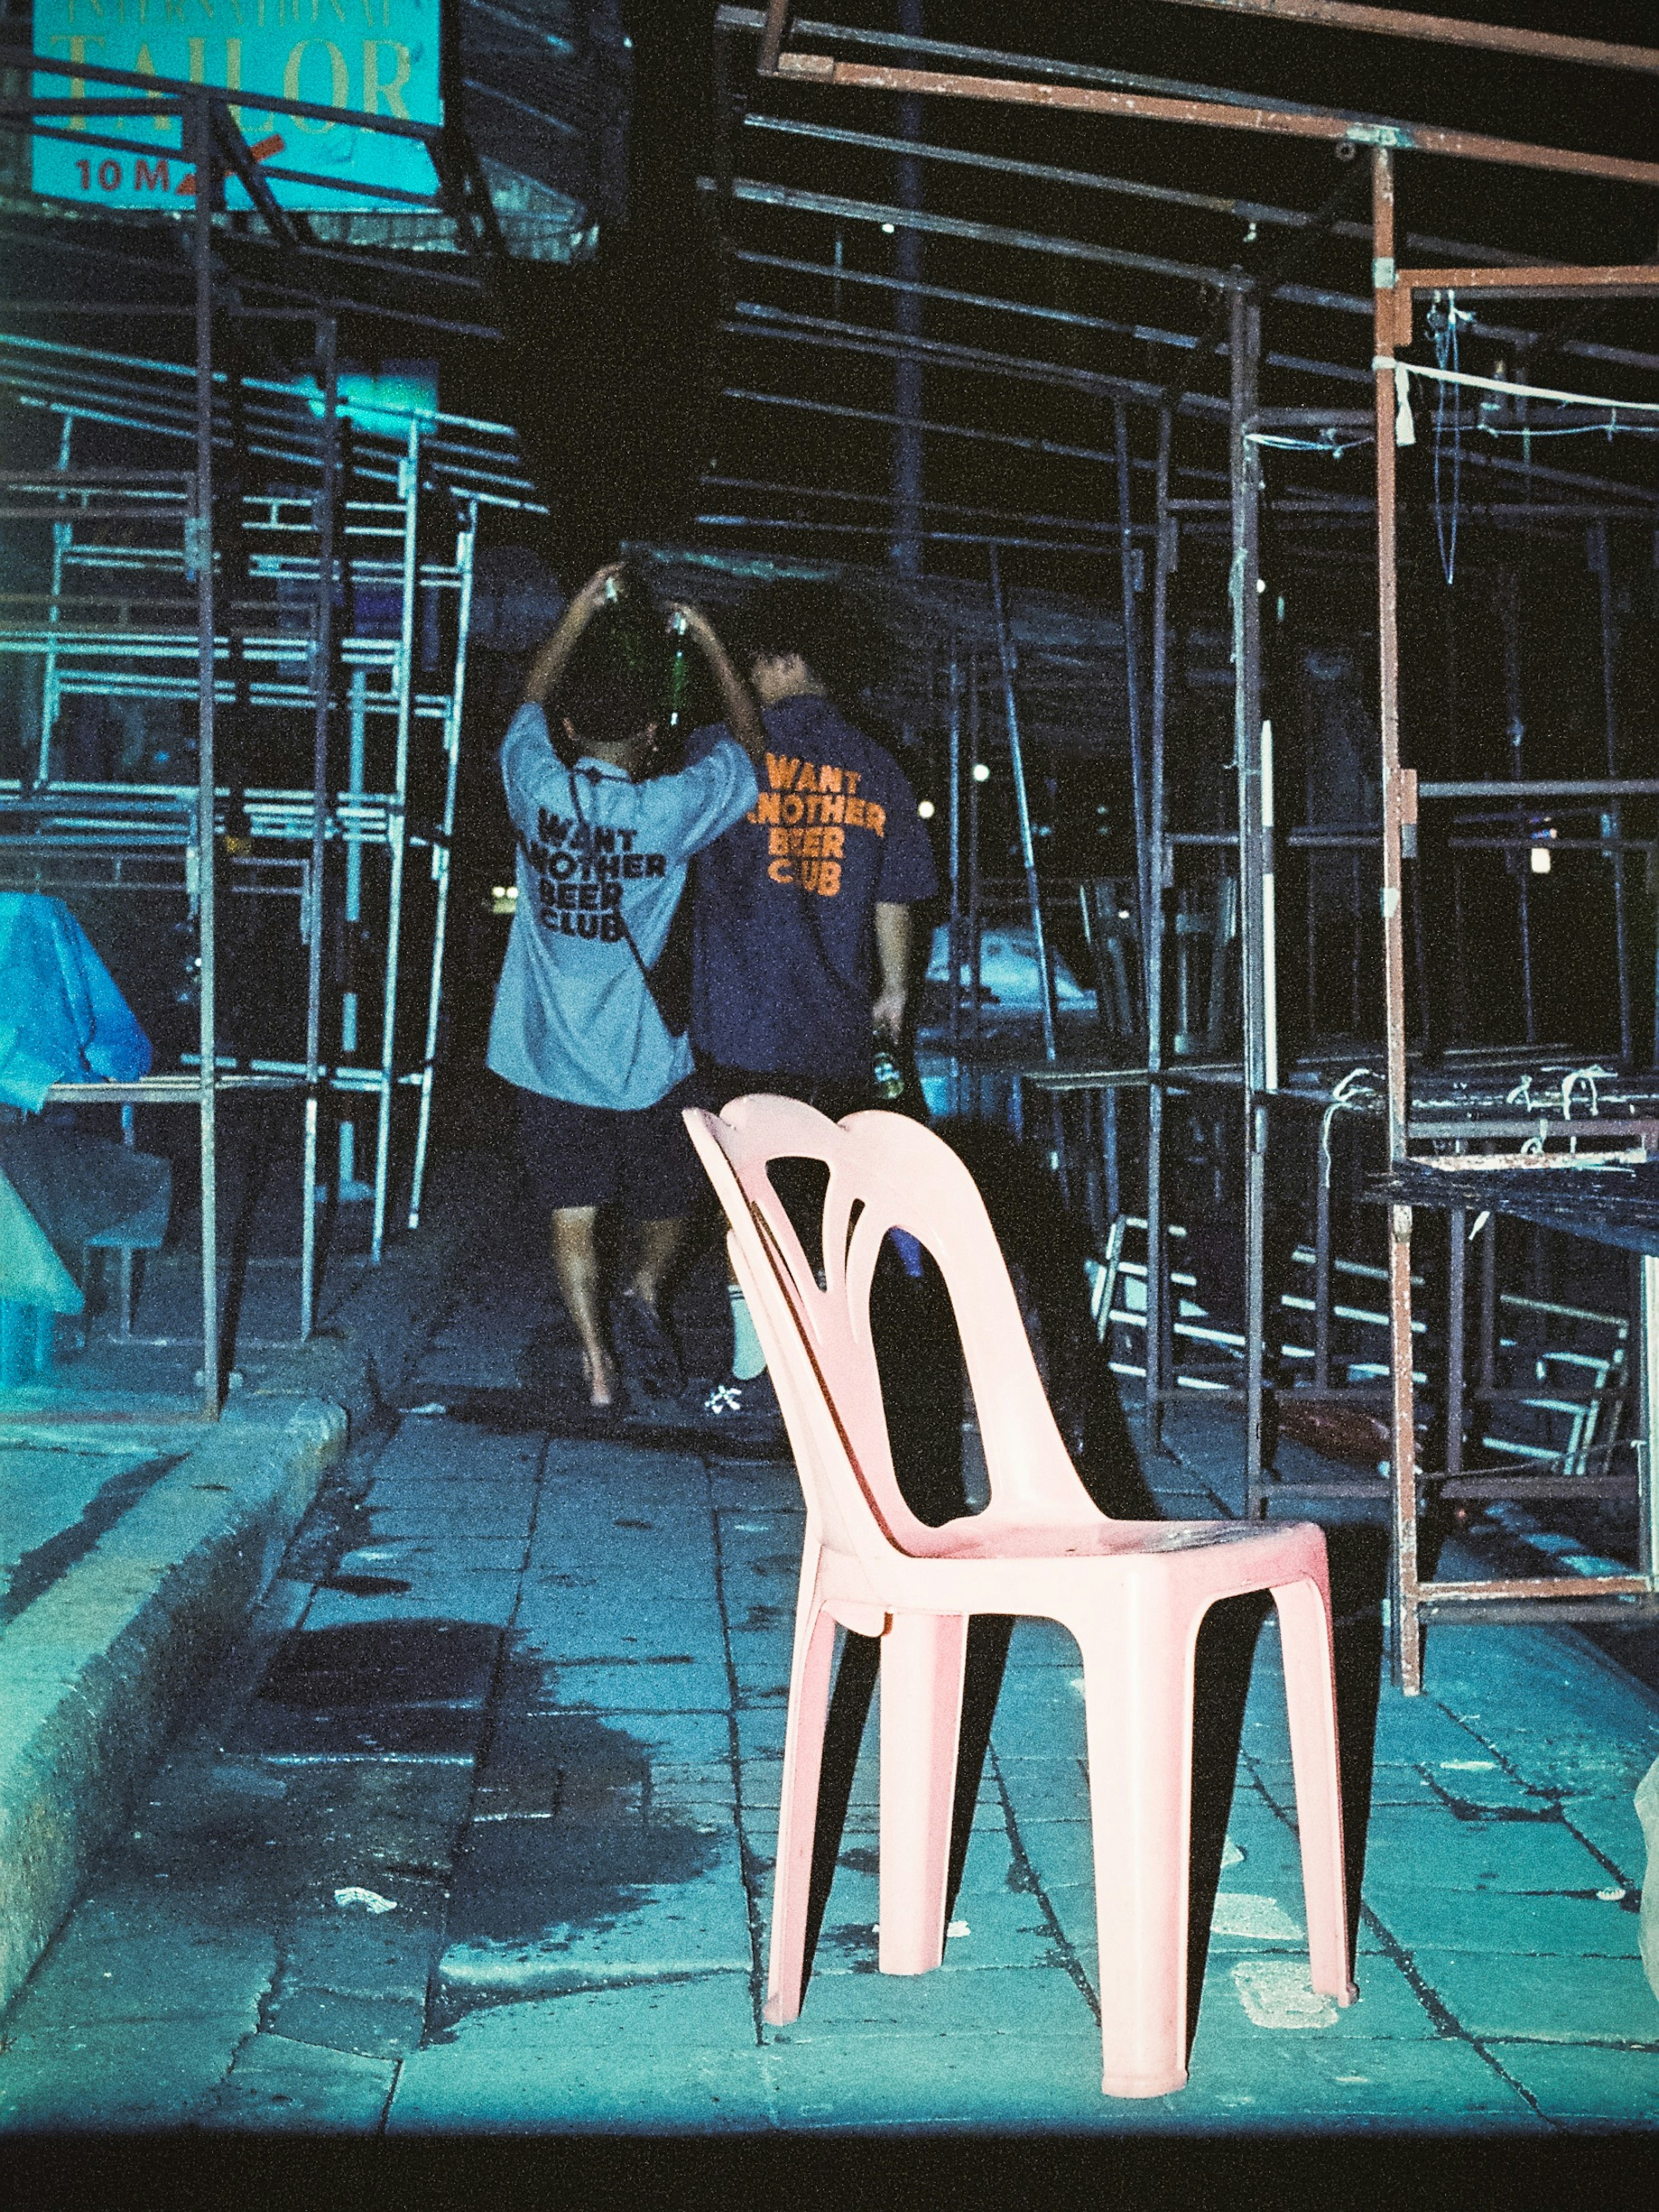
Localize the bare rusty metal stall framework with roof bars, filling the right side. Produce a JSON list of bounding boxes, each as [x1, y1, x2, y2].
[[721, 0, 1659, 1690]]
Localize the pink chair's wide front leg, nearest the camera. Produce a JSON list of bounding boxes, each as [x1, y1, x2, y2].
[[1073, 1617, 1197, 2097]]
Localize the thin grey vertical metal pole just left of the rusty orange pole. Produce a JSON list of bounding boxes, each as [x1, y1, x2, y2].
[[1228, 292, 1268, 1519]]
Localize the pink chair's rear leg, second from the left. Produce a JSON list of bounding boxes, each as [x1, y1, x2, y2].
[[876, 1612, 969, 1973]]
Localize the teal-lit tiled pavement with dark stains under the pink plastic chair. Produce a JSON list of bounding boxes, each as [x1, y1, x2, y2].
[[0, 1285, 1659, 2139]]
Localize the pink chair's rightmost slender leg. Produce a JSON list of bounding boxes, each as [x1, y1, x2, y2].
[[1274, 1582, 1358, 2004]]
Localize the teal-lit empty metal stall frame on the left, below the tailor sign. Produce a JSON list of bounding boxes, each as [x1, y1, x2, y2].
[[0, 55, 544, 1418]]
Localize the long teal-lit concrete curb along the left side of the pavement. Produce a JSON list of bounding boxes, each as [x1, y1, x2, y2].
[[0, 1159, 506, 2006]]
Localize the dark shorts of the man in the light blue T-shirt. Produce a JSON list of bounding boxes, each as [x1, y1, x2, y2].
[[518, 1075, 708, 1221]]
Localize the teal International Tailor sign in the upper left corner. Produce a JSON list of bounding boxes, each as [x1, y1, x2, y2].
[[33, 0, 442, 213]]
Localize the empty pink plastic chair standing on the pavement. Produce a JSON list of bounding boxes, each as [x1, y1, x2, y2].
[[686, 1097, 1356, 2097]]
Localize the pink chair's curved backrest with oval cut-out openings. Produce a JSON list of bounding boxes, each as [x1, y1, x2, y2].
[[686, 1095, 1102, 1557]]
